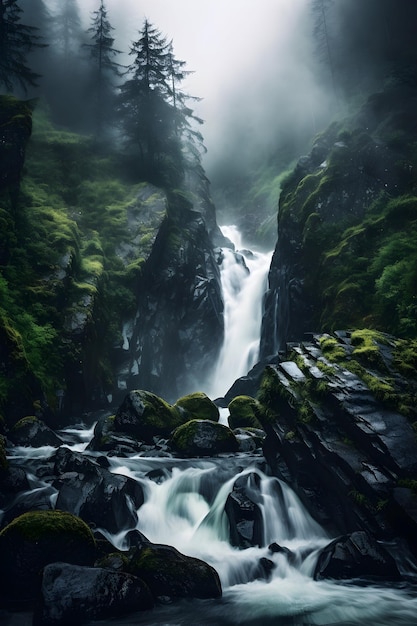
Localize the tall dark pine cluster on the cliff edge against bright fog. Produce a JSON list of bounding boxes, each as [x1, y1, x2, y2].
[[119, 20, 201, 184]]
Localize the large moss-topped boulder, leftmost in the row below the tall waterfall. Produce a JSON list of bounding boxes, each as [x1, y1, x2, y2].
[[114, 389, 185, 443]]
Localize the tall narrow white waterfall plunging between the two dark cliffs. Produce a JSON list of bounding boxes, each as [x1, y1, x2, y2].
[[207, 226, 272, 398]]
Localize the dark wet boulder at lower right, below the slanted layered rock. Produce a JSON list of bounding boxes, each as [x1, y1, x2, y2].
[[314, 531, 401, 581]]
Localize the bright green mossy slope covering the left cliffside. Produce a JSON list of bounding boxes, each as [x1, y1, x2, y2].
[[0, 97, 165, 418]]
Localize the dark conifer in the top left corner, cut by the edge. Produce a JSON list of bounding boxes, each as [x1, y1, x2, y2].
[[0, 0, 45, 93]]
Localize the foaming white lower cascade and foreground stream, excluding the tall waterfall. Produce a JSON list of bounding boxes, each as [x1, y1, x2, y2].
[[101, 448, 417, 626]]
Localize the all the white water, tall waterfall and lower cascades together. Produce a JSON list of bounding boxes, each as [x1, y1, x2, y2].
[[3, 227, 417, 626]]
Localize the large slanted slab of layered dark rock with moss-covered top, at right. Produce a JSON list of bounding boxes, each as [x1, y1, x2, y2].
[[255, 331, 417, 553]]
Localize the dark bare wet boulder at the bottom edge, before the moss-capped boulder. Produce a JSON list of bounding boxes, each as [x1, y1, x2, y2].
[[33, 563, 154, 626]]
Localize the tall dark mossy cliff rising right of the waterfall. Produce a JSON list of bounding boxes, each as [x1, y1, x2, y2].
[[260, 87, 417, 358]]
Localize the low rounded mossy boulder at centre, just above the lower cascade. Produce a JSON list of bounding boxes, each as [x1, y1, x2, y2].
[[170, 420, 239, 456]]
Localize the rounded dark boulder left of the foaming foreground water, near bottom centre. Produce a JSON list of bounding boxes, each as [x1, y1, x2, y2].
[[129, 544, 222, 598]]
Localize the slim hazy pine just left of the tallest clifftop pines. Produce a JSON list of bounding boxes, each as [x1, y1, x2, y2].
[[84, 0, 122, 135]]
